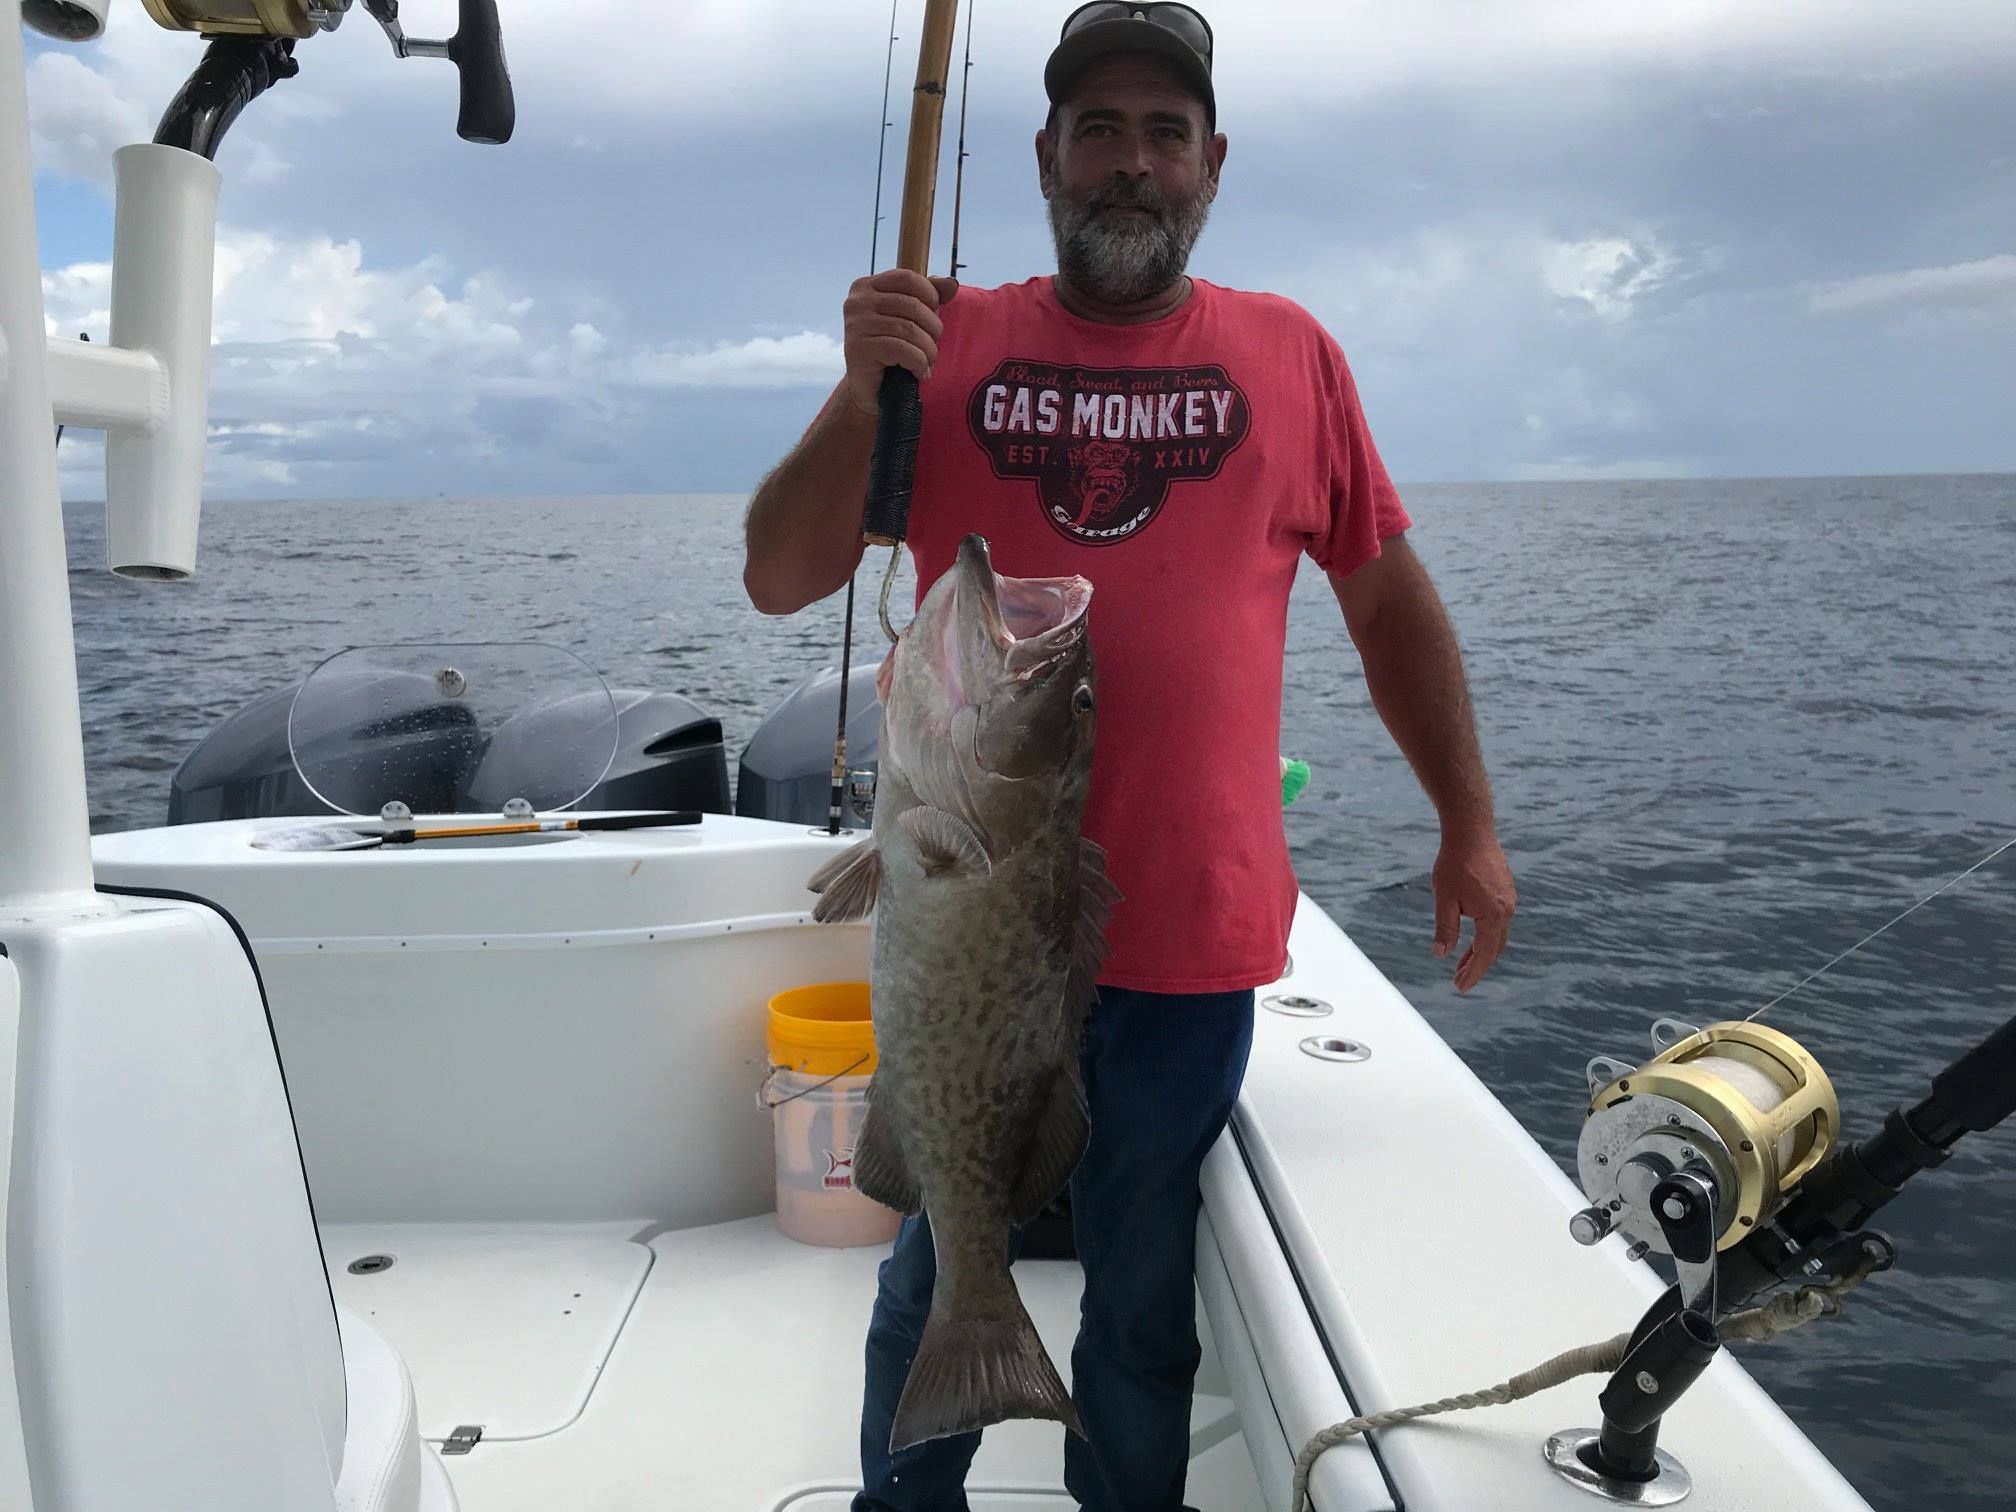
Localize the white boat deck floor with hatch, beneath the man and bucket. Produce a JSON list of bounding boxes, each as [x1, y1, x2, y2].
[[323, 1216, 1262, 1512]]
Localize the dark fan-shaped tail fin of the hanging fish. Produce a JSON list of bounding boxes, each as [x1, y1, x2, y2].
[[889, 1286, 1085, 1454]]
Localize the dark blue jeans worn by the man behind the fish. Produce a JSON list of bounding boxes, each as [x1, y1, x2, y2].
[[853, 988, 1254, 1512]]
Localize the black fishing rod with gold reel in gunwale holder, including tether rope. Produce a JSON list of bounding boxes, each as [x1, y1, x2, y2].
[[1290, 839, 2016, 1512]]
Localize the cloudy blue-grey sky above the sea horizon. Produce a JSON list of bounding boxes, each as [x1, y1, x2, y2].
[[28, 0, 2016, 498]]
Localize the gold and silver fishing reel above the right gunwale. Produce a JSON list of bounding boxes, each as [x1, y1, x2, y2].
[[1570, 1018, 1841, 1254]]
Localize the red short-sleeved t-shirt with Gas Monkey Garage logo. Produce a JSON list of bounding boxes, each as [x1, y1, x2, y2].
[[909, 276, 1409, 992]]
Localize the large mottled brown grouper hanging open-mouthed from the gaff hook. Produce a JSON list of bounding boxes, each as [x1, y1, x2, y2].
[[810, 536, 1119, 1452]]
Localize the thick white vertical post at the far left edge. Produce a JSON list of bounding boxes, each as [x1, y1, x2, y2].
[[0, 0, 103, 919]]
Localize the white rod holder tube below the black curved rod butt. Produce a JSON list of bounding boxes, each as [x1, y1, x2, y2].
[[105, 141, 222, 579]]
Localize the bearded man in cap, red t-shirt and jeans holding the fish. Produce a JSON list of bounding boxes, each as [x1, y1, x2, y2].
[[744, 0, 1514, 1512]]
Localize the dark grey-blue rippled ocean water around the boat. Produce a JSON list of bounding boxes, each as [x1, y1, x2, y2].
[[55, 478, 2016, 1512]]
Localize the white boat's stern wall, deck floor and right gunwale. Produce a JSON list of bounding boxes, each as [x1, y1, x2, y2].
[[78, 814, 1867, 1512]]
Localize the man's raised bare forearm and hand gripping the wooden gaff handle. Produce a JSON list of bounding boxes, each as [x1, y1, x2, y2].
[[742, 268, 958, 615]]
